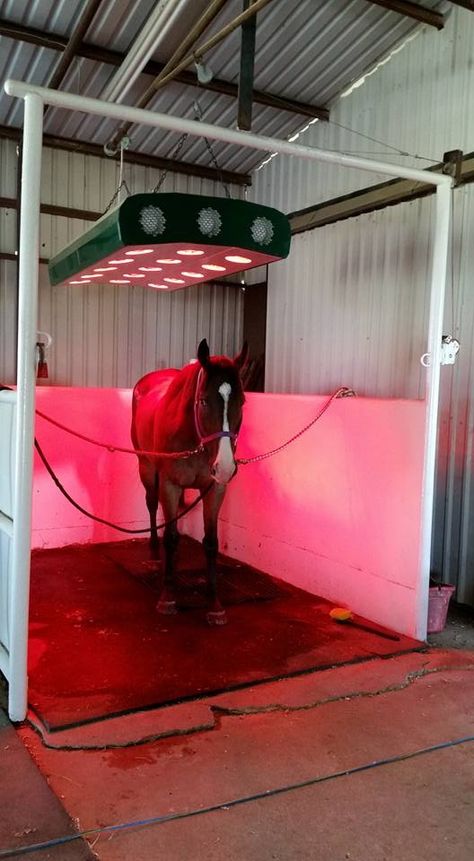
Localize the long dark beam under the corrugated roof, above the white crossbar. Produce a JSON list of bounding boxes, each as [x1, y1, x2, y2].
[[0, 19, 329, 120]]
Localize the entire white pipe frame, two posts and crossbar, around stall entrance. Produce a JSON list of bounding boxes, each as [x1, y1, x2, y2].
[[4, 80, 453, 720]]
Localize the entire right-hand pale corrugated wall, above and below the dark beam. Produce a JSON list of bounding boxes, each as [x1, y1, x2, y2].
[[252, 7, 474, 604]]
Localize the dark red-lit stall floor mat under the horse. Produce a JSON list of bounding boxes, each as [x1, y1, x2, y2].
[[29, 537, 420, 730]]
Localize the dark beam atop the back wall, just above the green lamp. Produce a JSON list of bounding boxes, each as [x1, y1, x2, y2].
[[0, 126, 252, 185]]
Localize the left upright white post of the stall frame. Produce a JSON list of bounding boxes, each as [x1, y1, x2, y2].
[[9, 94, 43, 721]]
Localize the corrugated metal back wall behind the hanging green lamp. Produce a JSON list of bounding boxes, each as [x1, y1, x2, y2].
[[0, 140, 243, 387]]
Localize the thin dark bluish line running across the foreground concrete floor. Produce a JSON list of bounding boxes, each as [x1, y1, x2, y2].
[[0, 735, 474, 858]]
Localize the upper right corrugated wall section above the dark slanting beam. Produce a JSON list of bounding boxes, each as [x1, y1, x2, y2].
[[252, 8, 474, 212]]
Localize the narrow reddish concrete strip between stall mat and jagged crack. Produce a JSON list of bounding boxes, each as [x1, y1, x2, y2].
[[28, 650, 474, 750]]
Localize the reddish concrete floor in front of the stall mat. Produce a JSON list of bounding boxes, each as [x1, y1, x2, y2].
[[0, 647, 474, 861]]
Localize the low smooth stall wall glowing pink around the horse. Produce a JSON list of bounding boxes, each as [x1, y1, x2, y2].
[[33, 387, 425, 636]]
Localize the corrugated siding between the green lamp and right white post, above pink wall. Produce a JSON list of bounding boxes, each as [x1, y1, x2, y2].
[[266, 200, 432, 398]]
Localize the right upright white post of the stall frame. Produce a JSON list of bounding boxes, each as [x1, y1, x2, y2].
[[416, 184, 451, 640]]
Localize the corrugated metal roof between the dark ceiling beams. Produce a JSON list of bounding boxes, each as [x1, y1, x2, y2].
[[0, 0, 450, 172]]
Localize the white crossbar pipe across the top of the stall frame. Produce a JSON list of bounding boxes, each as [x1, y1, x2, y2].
[[4, 78, 452, 185]]
